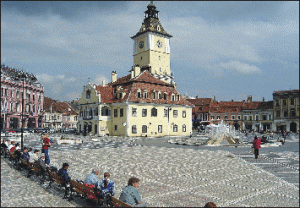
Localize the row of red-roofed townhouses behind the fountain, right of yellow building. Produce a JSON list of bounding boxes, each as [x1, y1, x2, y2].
[[187, 90, 299, 132]]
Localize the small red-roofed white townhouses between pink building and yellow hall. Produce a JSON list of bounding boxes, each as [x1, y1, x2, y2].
[[43, 97, 78, 130]]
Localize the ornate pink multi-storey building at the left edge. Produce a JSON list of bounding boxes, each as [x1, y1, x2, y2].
[[1, 65, 44, 129]]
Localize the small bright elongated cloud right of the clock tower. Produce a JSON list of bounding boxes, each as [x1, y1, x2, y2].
[[219, 61, 262, 74]]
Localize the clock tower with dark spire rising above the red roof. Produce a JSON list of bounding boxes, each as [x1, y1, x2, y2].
[[131, 1, 173, 82]]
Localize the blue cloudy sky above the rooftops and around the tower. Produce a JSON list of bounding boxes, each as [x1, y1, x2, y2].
[[1, 1, 299, 101]]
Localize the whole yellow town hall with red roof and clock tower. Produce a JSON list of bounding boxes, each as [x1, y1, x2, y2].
[[77, 3, 193, 137]]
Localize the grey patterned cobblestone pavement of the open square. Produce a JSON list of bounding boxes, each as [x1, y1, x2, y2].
[[1, 133, 299, 207]]
